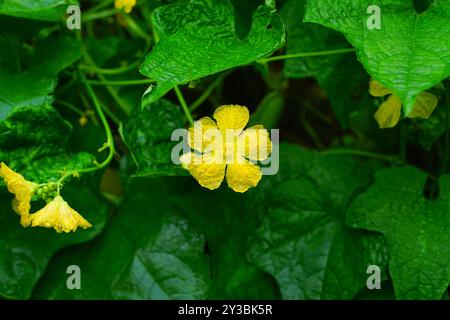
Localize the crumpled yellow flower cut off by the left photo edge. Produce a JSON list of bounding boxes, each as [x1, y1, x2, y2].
[[0, 162, 38, 217]]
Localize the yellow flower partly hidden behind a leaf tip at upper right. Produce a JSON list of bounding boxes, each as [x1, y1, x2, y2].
[[369, 80, 438, 129]]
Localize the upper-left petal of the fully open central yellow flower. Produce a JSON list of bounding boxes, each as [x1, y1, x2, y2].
[[188, 117, 222, 152]]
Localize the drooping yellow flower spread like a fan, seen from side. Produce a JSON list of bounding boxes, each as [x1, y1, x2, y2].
[[27, 196, 92, 233]]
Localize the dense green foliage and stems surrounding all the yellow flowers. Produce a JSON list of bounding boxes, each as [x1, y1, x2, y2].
[[0, 0, 450, 299]]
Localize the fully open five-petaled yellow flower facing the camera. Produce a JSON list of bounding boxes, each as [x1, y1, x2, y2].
[[180, 105, 272, 192]]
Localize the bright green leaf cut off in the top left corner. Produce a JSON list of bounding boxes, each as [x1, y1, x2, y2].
[[0, 0, 78, 21]]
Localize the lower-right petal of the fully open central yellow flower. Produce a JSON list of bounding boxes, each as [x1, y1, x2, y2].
[[227, 159, 262, 192]]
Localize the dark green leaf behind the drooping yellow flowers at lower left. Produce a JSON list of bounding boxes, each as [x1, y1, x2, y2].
[[0, 185, 107, 299]]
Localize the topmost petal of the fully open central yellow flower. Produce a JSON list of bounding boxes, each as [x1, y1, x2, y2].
[[214, 105, 250, 135]]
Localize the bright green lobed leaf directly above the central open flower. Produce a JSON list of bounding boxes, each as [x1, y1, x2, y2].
[[141, 0, 284, 103]]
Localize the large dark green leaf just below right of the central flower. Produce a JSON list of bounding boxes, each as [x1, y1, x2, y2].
[[249, 144, 386, 299]]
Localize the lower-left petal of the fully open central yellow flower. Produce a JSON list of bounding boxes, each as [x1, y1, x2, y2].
[[180, 152, 226, 190]]
